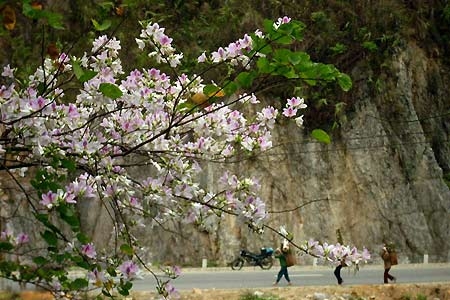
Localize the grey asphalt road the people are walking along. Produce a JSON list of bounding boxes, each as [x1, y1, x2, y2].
[[133, 264, 450, 291]]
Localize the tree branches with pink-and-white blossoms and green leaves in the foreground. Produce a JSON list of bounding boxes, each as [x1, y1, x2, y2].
[[0, 17, 358, 297]]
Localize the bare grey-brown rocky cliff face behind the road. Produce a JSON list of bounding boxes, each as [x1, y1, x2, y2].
[[139, 44, 450, 265]]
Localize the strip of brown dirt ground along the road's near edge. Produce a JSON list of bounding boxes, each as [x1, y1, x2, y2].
[[132, 282, 450, 300]]
